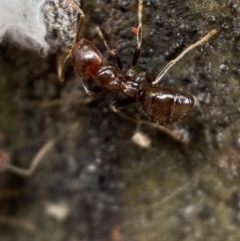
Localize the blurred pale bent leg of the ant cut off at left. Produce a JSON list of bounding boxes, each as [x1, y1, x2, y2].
[[5, 139, 56, 177]]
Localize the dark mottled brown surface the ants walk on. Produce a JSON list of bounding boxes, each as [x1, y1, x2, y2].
[[0, 0, 240, 241]]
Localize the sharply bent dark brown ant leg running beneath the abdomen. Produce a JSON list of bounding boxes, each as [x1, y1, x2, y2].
[[111, 99, 183, 143]]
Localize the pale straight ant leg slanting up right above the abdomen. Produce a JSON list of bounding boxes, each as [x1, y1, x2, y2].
[[152, 29, 217, 86]]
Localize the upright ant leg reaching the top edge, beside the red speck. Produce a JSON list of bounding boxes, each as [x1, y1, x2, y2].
[[127, 0, 143, 76]]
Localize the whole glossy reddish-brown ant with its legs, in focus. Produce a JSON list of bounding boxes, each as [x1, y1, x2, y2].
[[62, 0, 217, 140]]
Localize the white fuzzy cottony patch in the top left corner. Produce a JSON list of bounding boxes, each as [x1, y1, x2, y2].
[[0, 0, 49, 55]]
